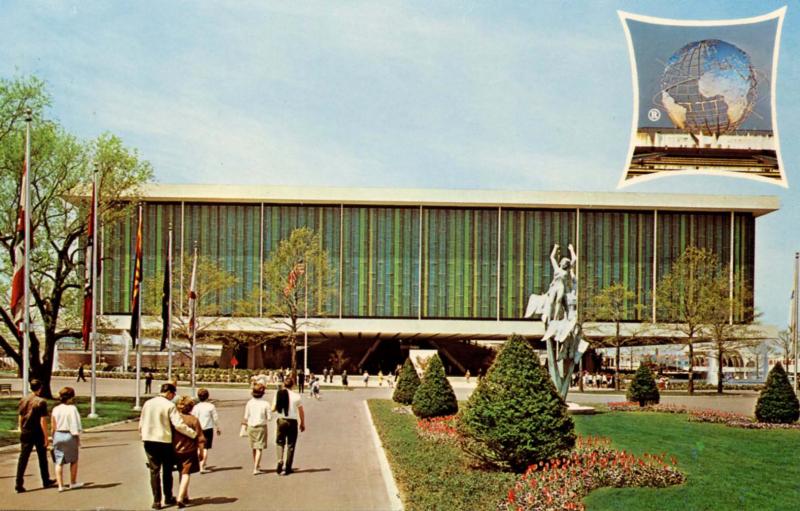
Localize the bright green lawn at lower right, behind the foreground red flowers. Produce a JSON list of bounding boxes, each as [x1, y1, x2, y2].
[[575, 412, 800, 511]]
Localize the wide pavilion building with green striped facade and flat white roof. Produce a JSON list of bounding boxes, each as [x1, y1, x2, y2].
[[100, 184, 779, 372]]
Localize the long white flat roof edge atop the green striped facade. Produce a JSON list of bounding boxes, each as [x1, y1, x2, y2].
[[133, 183, 780, 216]]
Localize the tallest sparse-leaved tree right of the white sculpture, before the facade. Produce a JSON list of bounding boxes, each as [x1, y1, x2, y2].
[[656, 246, 722, 394]]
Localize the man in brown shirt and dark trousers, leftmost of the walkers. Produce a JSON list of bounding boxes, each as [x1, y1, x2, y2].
[[14, 378, 56, 493]]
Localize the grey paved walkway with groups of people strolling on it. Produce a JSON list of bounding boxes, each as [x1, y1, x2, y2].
[[0, 380, 400, 510]]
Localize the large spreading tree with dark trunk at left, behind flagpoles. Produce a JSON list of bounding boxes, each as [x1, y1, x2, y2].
[[0, 78, 153, 397]]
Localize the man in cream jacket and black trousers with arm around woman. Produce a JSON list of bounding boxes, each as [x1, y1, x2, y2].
[[139, 382, 197, 509]]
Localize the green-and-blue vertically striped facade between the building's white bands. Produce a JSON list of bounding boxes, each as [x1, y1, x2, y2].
[[103, 202, 755, 321]]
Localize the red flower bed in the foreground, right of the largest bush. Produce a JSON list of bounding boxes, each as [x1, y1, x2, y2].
[[500, 437, 684, 511]]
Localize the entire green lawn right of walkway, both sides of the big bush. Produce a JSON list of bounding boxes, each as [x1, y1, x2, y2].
[[369, 400, 800, 511]]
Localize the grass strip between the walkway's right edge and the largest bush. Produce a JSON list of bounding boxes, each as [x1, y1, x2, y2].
[[369, 400, 516, 511]]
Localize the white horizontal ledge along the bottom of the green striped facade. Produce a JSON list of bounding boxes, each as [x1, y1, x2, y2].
[[103, 315, 778, 345]]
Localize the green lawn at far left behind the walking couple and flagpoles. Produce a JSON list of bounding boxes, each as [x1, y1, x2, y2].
[[0, 396, 139, 446]]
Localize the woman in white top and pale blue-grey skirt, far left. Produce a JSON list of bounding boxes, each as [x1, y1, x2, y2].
[[50, 387, 83, 491]]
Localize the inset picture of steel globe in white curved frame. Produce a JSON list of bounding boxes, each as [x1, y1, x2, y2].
[[618, 7, 788, 188]]
